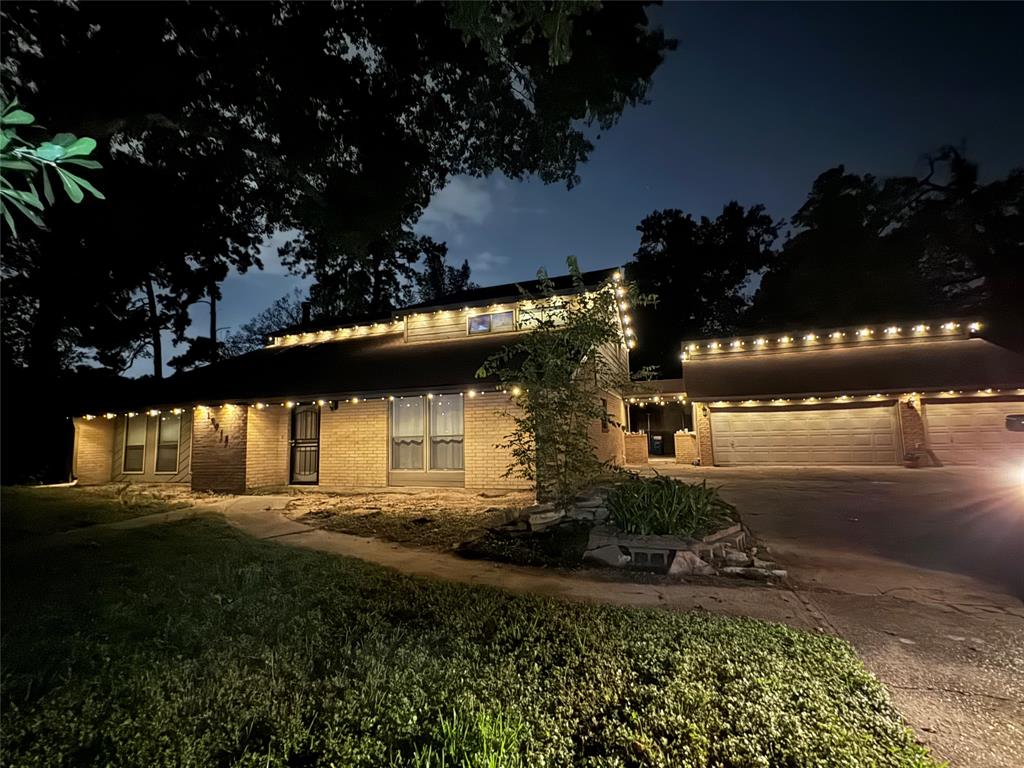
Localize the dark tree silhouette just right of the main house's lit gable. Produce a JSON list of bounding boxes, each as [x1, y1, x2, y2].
[[627, 202, 778, 371]]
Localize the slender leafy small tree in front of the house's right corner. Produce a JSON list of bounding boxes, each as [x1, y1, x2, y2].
[[477, 257, 647, 506]]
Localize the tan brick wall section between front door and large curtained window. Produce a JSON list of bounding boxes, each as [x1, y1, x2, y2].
[[319, 400, 388, 486]]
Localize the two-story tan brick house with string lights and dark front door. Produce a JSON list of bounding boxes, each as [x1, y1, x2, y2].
[[74, 269, 633, 493]]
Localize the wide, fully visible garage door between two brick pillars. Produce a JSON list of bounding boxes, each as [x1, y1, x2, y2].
[[711, 406, 897, 466]]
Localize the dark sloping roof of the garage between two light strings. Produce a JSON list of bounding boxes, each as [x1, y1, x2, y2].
[[683, 338, 1024, 400]]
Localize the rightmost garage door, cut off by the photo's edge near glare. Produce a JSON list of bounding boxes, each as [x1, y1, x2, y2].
[[925, 401, 1024, 464]]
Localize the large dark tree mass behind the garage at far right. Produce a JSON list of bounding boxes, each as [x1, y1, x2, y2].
[[748, 146, 1024, 344]]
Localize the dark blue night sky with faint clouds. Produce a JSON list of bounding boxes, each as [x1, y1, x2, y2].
[[148, 3, 1024, 374]]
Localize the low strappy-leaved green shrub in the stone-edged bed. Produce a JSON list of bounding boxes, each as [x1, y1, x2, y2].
[[608, 475, 739, 539]]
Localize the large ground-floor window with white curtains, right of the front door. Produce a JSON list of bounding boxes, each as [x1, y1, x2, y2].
[[391, 394, 465, 471]]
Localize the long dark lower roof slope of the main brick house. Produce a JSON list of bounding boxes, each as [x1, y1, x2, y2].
[[76, 333, 521, 413]]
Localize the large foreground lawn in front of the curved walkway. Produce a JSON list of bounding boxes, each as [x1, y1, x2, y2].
[[0, 492, 932, 768]]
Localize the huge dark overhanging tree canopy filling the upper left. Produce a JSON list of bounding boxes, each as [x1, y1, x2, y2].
[[0, 2, 674, 373]]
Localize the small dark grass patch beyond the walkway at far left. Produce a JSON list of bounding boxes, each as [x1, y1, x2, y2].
[[0, 484, 187, 539]]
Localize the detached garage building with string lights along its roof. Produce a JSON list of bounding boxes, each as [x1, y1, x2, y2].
[[647, 319, 1024, 466]]
